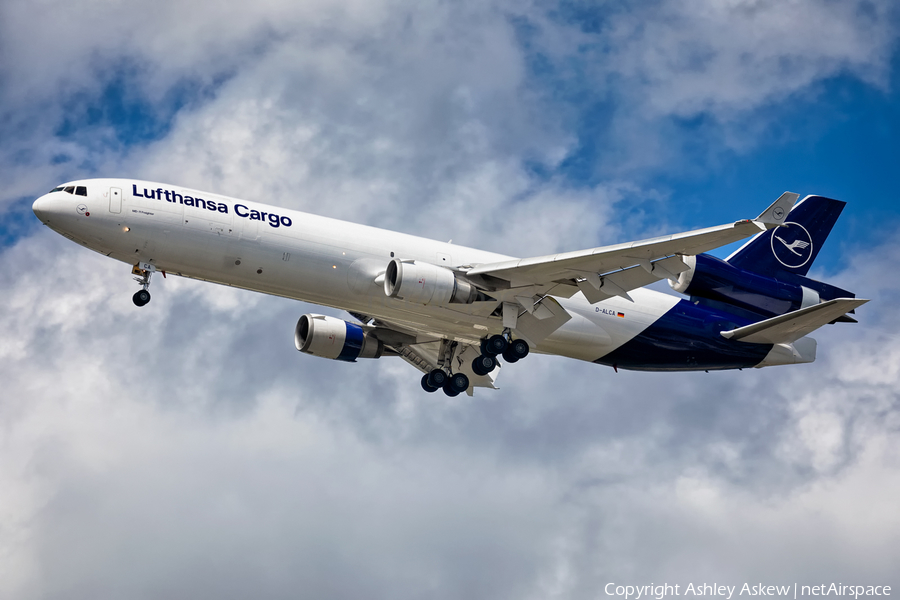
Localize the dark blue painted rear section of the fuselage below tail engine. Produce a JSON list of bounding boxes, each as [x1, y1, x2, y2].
[[594, 300, 772, 371]]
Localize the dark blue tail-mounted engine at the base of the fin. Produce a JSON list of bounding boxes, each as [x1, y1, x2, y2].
[[669, 254, 854, 316]]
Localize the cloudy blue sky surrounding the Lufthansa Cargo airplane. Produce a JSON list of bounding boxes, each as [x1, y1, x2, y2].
[[0, 0, 900, 600]]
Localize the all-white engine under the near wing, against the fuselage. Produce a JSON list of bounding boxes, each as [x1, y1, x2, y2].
[[384, 258, 479, 305]]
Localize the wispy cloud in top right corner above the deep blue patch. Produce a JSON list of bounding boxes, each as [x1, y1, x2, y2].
[[610, 0, 894, 119]]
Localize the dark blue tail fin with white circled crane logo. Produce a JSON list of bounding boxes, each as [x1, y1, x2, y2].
[[725, 196, 846, 279]]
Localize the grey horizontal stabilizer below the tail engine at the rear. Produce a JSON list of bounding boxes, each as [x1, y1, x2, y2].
[[722, 298, 868, 344]]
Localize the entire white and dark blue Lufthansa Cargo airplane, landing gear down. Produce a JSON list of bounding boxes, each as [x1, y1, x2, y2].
[[33, 179, 868, 397]]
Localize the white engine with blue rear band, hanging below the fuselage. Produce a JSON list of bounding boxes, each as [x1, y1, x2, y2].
[[294, 314, 384, 362]]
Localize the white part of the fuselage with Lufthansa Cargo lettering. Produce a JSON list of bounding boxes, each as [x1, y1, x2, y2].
[[34, 179, 678, 361]]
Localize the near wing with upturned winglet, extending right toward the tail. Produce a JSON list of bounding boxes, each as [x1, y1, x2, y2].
[[464, 192, 799, 304]]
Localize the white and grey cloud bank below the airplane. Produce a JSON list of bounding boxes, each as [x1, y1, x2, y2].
[[0, 225, 900, 598]]
